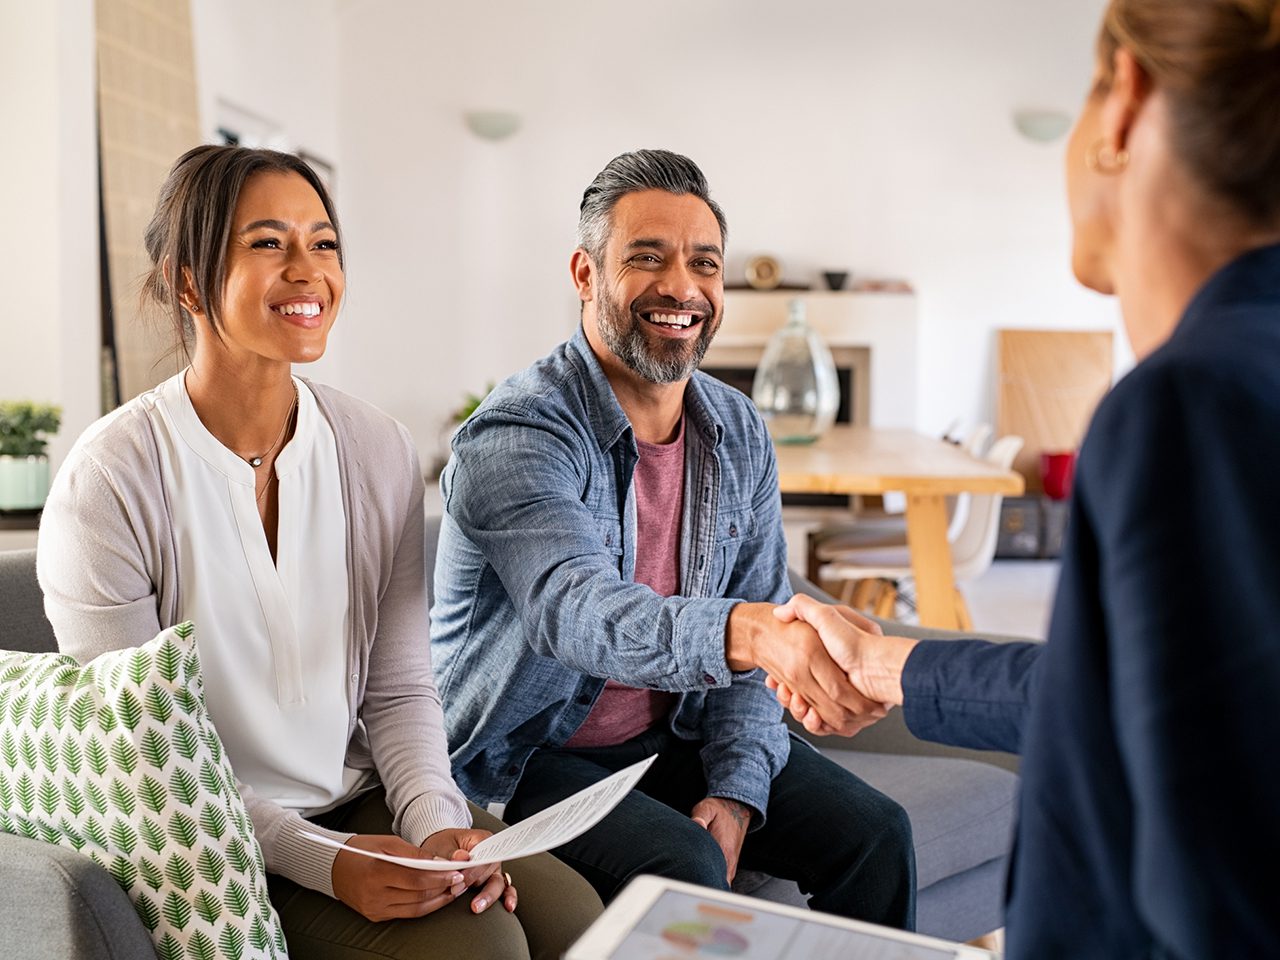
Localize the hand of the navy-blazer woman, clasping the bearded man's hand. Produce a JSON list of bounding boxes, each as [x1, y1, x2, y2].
[[765, 594, 916, 733]]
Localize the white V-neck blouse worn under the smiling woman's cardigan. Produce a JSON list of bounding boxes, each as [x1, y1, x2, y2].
[[150, 371, 369, 817]]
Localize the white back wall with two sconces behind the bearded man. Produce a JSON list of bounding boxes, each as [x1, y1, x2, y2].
[[338, 0, 1117, 457]]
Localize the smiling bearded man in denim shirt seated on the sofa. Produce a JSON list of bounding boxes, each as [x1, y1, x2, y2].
[[431, 150, 915, 928]]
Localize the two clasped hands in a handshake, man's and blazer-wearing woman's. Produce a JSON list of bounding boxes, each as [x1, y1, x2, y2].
[[726, 594, 916, 736]]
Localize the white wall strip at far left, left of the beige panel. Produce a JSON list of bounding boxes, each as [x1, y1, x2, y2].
[[0, 0, 101, 463]]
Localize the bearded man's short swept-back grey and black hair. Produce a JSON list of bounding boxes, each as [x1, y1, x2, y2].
[[577, 150, 728, 264]]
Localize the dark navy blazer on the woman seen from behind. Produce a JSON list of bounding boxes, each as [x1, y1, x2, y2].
[[904, 246, 1280, 960]]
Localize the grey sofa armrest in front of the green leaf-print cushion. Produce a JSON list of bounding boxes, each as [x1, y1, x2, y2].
[[0, 833, 156, 960]]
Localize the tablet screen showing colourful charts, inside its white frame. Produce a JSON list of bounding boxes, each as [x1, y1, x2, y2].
[[609, 890, 956, 960]]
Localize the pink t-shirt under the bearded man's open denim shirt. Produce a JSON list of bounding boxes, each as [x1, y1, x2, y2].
[[564, 419, 685, 746]]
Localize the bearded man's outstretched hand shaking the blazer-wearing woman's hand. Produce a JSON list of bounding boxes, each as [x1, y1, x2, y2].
[[724, 603, 886, 736]]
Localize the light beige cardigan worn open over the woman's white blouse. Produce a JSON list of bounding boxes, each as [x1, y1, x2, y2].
[[36, 381, 471, 896]]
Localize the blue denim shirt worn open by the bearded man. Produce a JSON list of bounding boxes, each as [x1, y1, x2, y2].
[[431, 329, 791, 828]]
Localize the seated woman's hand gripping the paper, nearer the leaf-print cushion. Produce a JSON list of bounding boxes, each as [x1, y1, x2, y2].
[[333, 831, 479, 922]]
